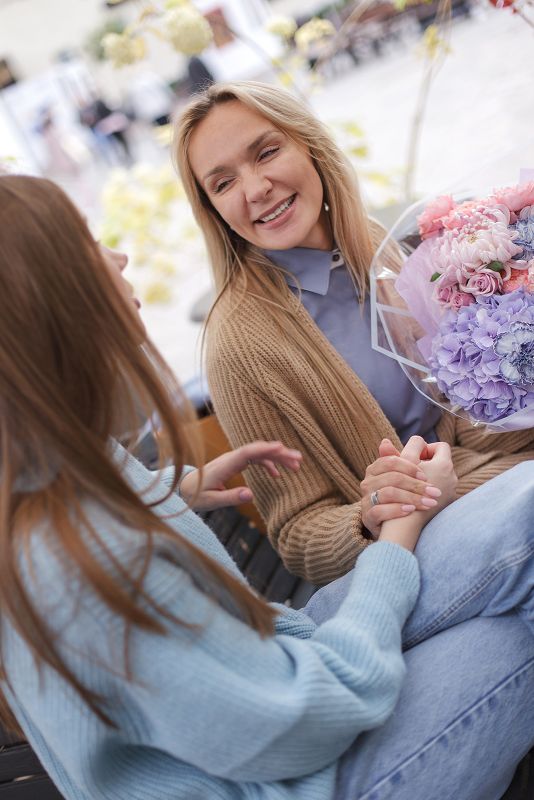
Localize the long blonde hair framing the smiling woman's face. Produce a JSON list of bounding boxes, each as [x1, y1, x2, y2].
[[173, 81, 383, 310]]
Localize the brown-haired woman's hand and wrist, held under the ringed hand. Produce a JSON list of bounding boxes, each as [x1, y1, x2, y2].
[[379, 436, 458, 550]]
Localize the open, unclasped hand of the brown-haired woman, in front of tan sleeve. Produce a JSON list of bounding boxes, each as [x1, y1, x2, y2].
[[180, 442, 302, 511]]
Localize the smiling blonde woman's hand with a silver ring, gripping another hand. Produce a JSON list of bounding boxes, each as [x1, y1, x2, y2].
[[360, 436, 441, 536]]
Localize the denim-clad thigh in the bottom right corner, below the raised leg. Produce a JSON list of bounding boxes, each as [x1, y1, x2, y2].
[[335, 615, 534, 800]]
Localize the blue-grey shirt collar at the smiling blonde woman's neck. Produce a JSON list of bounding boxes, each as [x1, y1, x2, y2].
[[263, 247, 344, 296]]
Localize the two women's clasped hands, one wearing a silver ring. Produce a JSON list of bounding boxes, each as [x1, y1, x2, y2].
[[360, 436, 458, 537]]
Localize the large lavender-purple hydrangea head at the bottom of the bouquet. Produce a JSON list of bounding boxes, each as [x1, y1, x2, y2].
[[430, 289, 534, 422]]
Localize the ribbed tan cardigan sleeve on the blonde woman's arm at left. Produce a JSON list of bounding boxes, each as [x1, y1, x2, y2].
[[208, 342, 370, 585]]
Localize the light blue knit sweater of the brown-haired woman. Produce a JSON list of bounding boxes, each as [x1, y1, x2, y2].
[[4, 448, 419, 800]]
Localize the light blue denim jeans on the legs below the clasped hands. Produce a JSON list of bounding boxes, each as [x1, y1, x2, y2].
[[305, 462, 534, 800]]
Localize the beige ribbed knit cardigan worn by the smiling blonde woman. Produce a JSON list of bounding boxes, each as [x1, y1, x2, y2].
[[206, 295, 534, 584]]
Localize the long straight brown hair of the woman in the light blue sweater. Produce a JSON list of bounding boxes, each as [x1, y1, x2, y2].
[[0, 175, 273, 725]]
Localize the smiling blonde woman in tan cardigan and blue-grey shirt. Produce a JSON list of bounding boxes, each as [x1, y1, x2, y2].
[[175, 82, 534, 584]]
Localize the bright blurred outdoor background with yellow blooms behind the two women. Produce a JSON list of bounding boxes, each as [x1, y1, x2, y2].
[[0, 0, 534, 382]]
